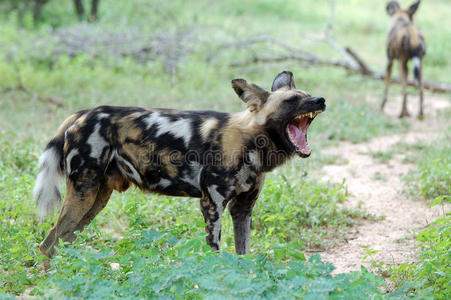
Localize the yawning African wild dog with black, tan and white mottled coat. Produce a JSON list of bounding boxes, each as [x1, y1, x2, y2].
[[34, 71, 326, 257]]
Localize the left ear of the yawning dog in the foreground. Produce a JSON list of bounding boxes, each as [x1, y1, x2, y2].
[[232, 78, 269, 111]]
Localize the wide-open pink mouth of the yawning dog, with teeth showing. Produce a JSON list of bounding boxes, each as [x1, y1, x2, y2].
[[286, 110, 321, 157]]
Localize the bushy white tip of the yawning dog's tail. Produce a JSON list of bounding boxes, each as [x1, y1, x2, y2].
[[33, 148, 63, 220]]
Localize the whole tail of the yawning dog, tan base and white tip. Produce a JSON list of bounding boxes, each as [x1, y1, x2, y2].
[[33, 113, 81, 220]]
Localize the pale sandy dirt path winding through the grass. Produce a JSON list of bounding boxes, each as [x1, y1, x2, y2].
[[320, 96, 450, 274]]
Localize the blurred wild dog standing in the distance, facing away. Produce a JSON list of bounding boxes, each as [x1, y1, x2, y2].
[[381, 1, 426, 118]]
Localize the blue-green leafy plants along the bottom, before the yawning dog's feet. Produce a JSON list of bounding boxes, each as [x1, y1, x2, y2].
[[33, 229, 392, 299]]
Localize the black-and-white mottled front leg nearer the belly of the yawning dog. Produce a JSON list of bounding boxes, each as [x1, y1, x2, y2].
[[200, 185, 227, 251]]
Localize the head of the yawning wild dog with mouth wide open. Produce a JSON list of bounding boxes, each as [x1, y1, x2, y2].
[[232, 71, 326, 157]]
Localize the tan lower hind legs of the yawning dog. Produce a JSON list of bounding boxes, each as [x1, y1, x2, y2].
[[40, 179, 100, 257]]
